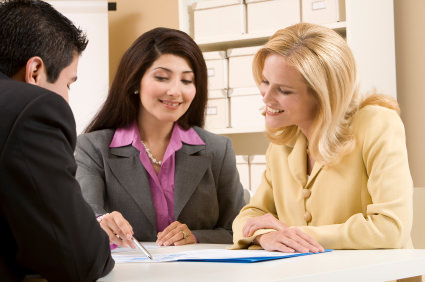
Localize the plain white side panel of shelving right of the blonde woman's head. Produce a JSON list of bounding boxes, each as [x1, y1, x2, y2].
[[345, 0, 397, 98]]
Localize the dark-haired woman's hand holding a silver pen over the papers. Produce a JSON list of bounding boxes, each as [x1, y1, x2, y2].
[[98, 211, 136, 249]]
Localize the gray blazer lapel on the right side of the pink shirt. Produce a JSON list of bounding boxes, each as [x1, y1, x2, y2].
[[174, 144, 211, 219]]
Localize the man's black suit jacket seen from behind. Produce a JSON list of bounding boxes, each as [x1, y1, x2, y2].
[[0, 73, 114, 281]]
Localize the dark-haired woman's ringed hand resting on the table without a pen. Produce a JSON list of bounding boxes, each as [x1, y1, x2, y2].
[[156, 221, 196, 246]]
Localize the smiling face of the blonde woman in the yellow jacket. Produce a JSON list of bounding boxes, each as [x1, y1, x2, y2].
[[259, 54, 317, 137]]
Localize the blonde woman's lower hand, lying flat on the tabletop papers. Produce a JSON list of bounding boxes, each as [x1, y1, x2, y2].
[[254, 227, 324, 253]]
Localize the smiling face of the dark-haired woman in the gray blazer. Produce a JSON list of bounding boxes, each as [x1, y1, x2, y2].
[[139, 54, 196, 126]]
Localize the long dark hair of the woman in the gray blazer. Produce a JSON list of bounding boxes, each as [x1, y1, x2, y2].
[[85, 27, 208, 132]]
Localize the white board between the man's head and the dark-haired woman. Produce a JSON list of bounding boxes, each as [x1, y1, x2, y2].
[[47, 0, 109, 134]]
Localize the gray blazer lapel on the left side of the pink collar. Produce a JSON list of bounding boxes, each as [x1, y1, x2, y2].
[[108, 146, 156, 230]]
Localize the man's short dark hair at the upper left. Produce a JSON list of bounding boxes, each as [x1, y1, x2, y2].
[[0, 0, 88, 83]]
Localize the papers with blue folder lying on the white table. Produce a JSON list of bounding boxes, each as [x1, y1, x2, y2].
[[112, 245, 331, 263]]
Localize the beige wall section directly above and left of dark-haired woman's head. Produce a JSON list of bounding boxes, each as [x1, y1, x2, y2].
[[108, 0, 179, 82]]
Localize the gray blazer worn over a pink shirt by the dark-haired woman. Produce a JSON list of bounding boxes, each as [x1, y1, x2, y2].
[[76, 127, 245, 243]]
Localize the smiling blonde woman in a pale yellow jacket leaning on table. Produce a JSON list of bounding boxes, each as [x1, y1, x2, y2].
[[233, 23, 413, 252]]
